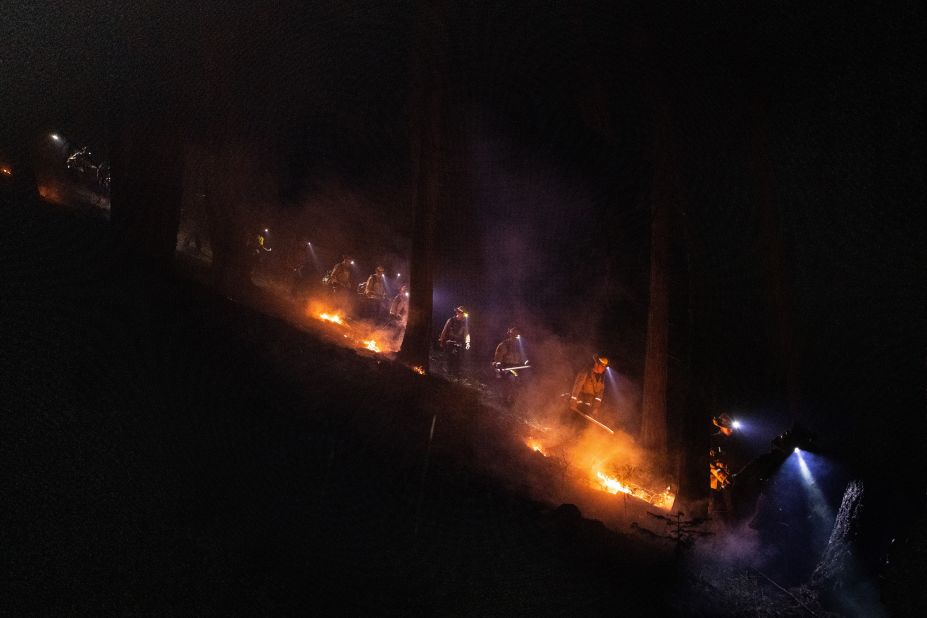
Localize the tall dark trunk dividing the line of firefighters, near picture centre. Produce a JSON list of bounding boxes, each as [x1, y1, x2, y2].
[[398, 3, 447, 369]]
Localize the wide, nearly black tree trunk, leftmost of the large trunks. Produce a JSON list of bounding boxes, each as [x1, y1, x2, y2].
[[109, 3, 190, 269]]
